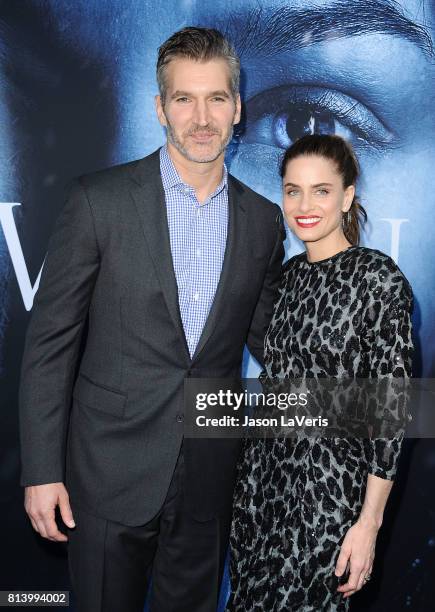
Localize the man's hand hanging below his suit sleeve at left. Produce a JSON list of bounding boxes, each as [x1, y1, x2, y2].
[[24, 482, 75, 542]]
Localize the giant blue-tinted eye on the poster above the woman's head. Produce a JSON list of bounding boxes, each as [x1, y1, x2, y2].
[[235, 86, 395, 151]]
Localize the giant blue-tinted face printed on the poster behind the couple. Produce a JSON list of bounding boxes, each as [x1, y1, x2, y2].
[[0, 0, 435, 375]]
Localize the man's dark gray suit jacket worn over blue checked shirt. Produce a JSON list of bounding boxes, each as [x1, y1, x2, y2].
[[20, 151, 285, 525]]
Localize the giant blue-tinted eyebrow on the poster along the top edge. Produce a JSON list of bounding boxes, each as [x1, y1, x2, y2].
[[220, 0, 434, 57]]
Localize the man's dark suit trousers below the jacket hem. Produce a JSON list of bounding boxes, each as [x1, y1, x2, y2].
[[68, 442, 231, 612]]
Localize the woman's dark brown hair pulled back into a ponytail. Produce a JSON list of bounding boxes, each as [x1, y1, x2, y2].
[[280, 134, 367, 245]]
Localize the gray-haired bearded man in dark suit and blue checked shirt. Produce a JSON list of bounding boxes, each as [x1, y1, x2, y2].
[[20, 28, 285, 612]]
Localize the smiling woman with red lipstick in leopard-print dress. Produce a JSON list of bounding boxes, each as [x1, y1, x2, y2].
[[227, 135, 412, 612]]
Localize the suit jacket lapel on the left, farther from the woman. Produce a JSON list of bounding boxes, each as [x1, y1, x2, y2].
[[131, 151, 190, 361]]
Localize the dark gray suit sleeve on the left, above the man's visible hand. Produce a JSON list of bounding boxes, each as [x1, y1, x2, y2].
[[19, 181, 99, 486]]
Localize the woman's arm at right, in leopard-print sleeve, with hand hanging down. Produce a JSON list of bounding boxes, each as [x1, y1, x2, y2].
[[335, 258, 413, 597]]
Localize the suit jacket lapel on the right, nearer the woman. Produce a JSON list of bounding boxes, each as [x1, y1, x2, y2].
[[192, 175, 247, 361]]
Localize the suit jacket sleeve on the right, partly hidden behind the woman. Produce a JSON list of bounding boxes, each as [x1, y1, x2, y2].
[[247, 206, 286, 366]]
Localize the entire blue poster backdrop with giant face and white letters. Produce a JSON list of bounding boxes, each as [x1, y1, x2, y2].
[[0, 0, 435, 612]]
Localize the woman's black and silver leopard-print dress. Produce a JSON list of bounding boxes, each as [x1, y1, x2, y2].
[[226, 246, 412, 612]]
